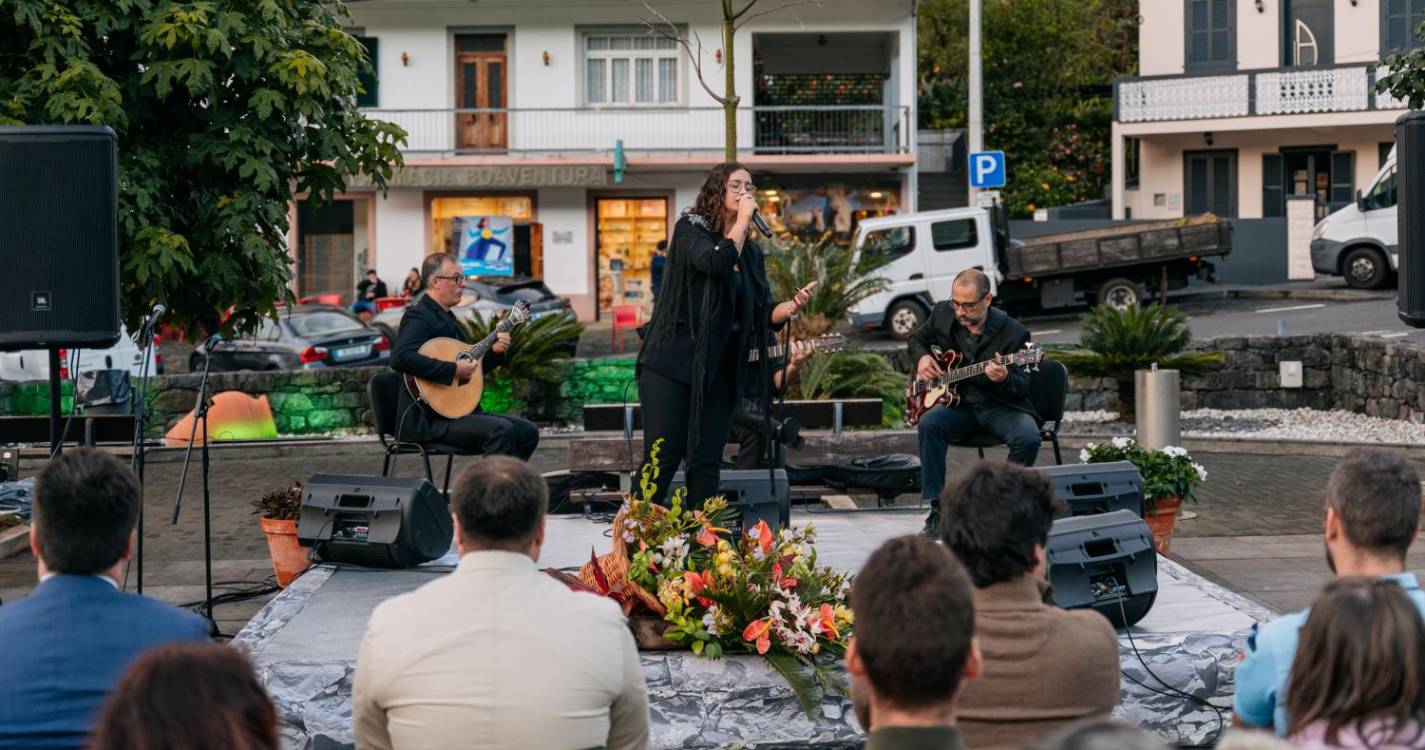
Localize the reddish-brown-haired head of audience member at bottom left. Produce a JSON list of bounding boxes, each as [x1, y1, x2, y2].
[[90, 643, 278, 750]]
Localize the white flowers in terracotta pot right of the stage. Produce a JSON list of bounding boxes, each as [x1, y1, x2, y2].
[[1079, 438, 1207, 555]]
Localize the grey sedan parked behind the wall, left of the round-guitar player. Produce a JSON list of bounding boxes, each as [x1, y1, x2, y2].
[[188, 305, 390, 372]]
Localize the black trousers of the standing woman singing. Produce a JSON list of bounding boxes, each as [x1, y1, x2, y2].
[[634, 368, 737, 508]]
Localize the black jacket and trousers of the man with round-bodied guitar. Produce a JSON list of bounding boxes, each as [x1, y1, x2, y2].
[[390, 294, 539, 461]]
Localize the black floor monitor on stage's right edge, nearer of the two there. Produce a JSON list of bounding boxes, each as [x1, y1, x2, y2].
[[1045, 510, 1157, 627]]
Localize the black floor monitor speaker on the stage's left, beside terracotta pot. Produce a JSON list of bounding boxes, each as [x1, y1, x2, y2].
[[296, 473, 455, 567]]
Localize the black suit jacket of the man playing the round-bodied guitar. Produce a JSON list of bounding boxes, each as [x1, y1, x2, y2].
[[390, 294, 504, 442]]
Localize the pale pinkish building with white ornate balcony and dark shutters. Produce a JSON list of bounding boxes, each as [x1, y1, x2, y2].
[[1112, 0, 1425, 220]]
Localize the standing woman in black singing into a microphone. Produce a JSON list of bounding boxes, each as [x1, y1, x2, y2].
[[638, 161, 815, 508]]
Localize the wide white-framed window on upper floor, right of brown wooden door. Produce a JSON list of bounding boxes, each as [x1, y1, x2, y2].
[[584, 33, 683, 107]]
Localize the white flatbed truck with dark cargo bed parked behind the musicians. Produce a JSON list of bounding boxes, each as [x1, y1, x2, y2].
[[851, 202, 1231, 341]]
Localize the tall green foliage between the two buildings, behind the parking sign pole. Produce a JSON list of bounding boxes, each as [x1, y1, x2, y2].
[[919, 0, 1137, 215]]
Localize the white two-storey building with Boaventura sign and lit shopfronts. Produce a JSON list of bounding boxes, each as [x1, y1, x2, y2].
[[289, 0, 916, 319]]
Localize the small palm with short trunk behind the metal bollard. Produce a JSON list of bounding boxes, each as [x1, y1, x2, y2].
[[1047, 302, 1224, 422]]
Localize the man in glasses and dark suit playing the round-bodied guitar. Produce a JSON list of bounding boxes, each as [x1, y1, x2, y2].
[[390, 252, 539, 461]]
